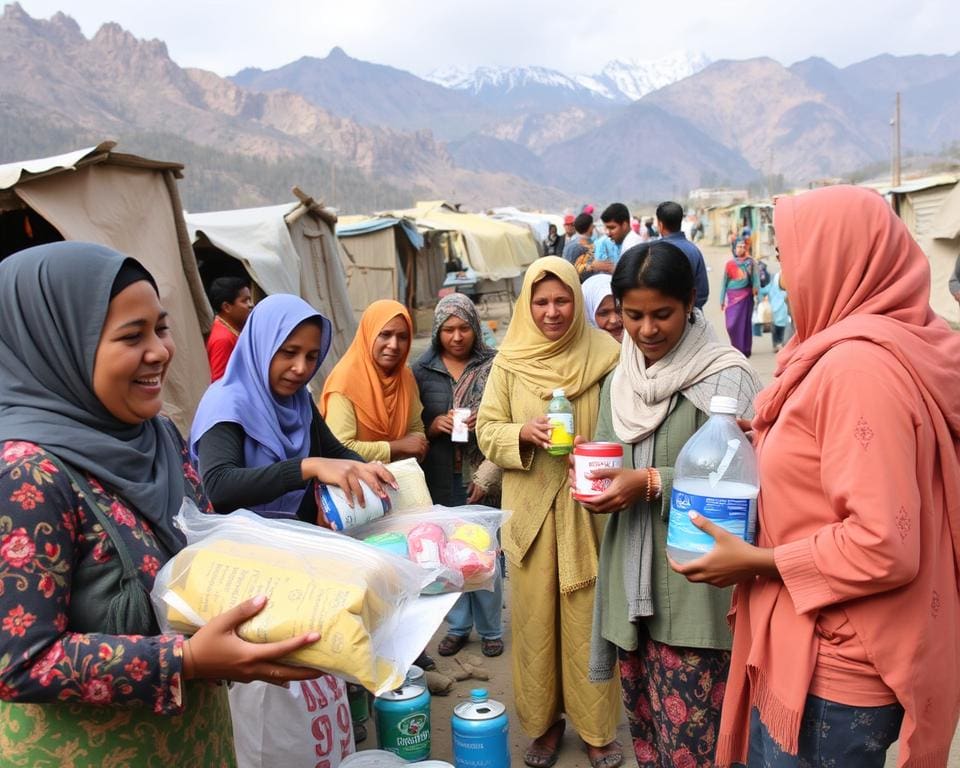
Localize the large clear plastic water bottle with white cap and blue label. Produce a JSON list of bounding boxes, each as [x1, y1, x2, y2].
[[667, 396, 760, 563]]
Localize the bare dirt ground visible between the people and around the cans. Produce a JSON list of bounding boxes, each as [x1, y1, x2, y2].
[[361, 247, 960, 768]]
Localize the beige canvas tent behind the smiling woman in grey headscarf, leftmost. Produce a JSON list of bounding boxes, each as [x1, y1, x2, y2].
[[0, 141, 212, 432]]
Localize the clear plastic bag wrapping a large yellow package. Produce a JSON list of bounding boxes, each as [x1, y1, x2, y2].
[[151, 499, 439, 694]]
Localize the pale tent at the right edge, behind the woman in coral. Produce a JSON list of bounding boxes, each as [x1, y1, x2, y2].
[[880, 173, 960, 323]]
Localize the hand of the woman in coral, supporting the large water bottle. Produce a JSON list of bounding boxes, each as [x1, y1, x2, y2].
[[667, 513, 780, 587]]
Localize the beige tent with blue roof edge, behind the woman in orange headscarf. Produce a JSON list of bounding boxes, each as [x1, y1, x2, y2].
[[337, 215, 446, 316]]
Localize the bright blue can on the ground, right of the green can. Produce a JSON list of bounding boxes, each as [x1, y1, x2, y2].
[[451, 688, 510, 768]]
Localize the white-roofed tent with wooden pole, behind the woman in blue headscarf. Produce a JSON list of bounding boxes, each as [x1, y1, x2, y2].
[[185, 190, 357, 383]]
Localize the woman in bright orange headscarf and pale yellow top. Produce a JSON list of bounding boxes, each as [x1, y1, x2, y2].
[[320, 299, 429, 461]]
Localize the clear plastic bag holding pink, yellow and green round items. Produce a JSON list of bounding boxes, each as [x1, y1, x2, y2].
[[347, 505, 510, 595]]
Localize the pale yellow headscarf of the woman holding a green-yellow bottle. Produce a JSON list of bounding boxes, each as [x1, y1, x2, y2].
[[494, 256, 620, 402]]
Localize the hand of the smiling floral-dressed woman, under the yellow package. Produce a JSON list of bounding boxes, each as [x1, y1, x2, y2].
[[183, 595, 320, 685]]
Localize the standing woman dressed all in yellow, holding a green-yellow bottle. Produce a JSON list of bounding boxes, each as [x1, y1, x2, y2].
[[477, 256, 623, 768]]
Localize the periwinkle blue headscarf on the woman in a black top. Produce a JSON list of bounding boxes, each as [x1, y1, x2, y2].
[[190, 294, 331, 517]]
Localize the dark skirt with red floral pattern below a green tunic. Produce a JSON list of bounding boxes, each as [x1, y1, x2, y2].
[[619, 628, 730, 768]]
